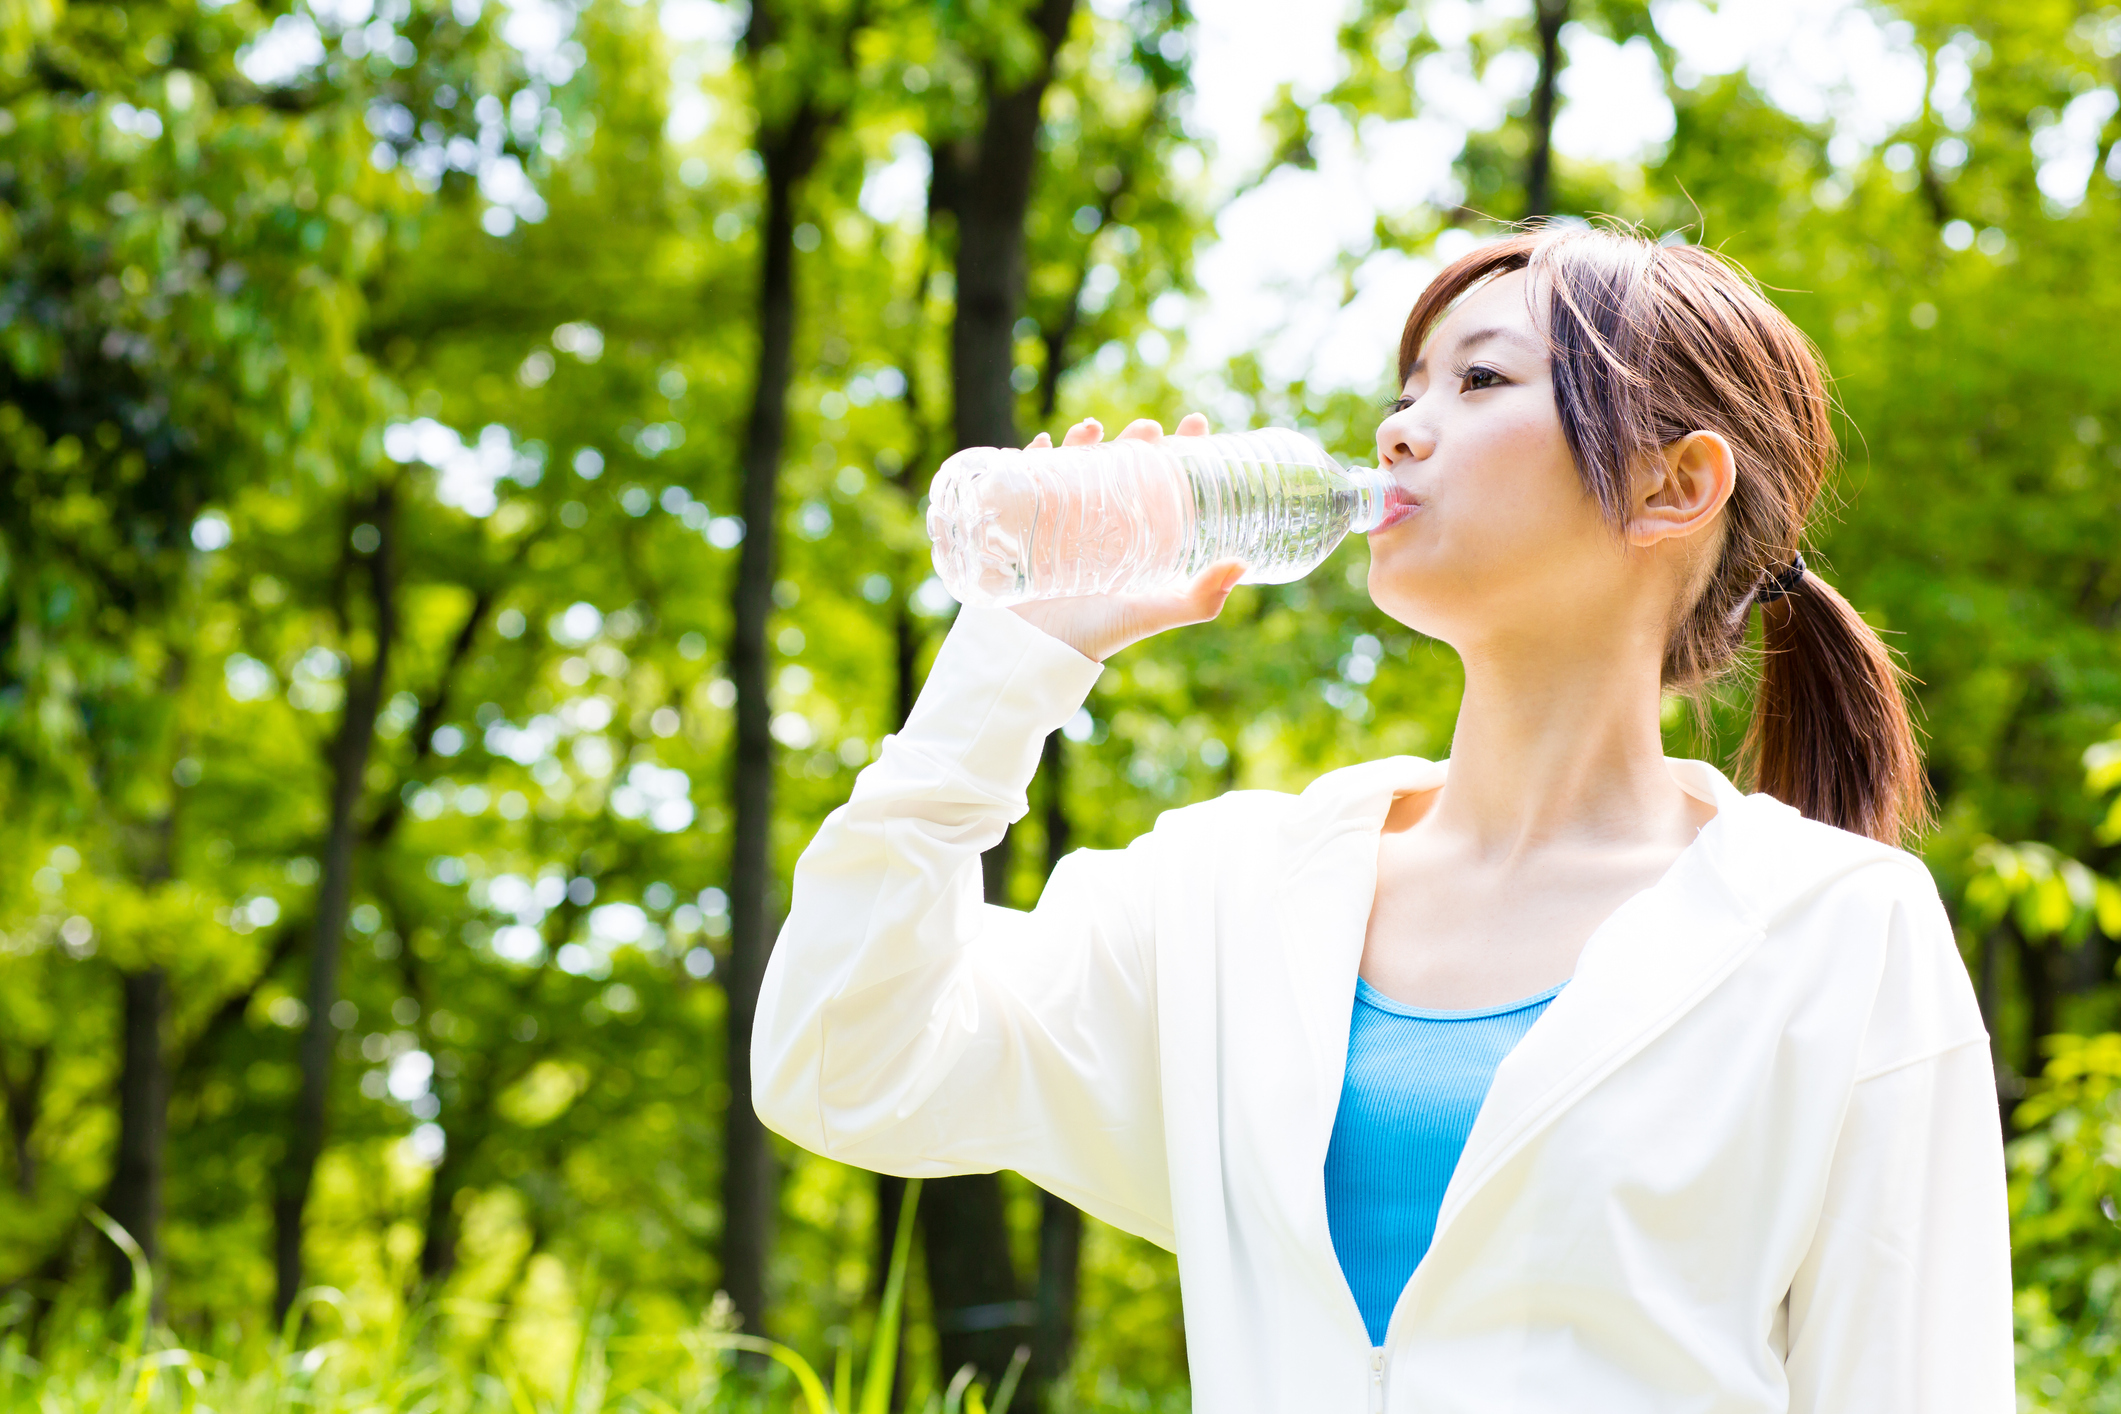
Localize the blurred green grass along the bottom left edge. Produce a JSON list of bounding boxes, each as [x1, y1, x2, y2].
[[0, 1181, 1056, 1414]]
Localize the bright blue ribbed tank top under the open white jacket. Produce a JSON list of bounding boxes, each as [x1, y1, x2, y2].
[[1326, 977, 1567, 1346]]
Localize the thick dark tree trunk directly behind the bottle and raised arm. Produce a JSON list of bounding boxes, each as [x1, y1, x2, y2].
[[921, 0, 1075, 1384]]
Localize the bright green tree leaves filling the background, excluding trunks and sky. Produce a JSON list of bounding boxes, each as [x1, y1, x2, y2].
[[12, 0, 2121, 1408]]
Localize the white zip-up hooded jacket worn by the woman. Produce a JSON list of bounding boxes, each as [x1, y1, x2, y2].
[[753, 608, 2015, 1414]]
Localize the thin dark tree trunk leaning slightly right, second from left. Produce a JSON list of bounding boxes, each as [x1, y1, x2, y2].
[[274, 488, 397, 1321]]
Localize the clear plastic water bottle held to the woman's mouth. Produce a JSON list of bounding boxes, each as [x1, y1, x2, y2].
[[927, 428, 1400, 604]]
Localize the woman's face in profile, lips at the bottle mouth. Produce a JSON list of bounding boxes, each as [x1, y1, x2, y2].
[[1370, 271, 1627, 651]]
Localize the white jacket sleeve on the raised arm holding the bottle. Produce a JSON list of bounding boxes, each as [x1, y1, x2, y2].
[[751, 606, 1173, 1247]]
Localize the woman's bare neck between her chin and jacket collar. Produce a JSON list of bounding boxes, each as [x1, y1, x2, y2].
[[1430, 625, 1703, 859]]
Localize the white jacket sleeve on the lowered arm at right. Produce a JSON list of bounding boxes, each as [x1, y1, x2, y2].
[[1788, 871, 2017, 1414]]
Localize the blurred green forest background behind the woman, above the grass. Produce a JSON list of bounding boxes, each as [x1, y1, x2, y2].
[[0, 0, 2121, 1414]]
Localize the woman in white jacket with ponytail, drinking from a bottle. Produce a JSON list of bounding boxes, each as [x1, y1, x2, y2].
[[753, 229, 2013, 1414]]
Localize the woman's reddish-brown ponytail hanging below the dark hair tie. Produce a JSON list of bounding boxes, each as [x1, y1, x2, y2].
[[1741, 572, 1930, 844]]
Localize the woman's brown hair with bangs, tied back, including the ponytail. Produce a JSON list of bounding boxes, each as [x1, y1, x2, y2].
[[1400, 225, 1930, 844]]
